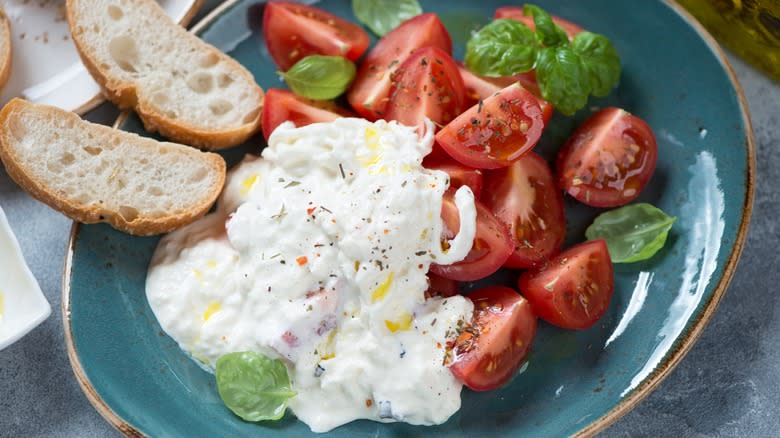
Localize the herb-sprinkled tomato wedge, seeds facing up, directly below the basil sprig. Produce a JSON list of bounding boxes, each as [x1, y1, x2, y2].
[[436, 83, 544, 169]]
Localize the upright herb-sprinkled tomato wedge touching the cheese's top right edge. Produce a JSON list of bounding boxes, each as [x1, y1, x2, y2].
[[384, 47, 466, 130]]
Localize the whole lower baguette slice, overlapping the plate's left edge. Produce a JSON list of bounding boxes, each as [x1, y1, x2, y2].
[[0, 99, 226, 235]]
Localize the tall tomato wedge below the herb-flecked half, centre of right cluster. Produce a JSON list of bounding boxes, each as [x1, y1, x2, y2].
[[482, 152, 566, 269]]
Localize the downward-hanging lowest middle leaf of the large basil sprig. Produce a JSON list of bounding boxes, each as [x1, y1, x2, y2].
[[536, 47, 590, 116]]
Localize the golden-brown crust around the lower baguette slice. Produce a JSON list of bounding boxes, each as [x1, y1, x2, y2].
[[0, 98, 227, 236]]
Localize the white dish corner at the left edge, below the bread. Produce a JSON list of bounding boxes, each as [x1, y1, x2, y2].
[[0, 207, 51, 350]]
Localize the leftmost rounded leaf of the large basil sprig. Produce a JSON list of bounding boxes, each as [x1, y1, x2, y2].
[[465, 19, 538, 76]]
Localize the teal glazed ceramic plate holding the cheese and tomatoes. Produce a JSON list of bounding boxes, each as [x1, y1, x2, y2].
[[62, 0, 754, 437]]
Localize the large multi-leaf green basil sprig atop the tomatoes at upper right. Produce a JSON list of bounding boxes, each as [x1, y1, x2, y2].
[[465, 4, 620, 115]]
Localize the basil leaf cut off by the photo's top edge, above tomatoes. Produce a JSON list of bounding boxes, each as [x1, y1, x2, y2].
[[352, 0, 422, 36]]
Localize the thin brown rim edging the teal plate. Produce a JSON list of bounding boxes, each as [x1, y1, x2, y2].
[[61, 0, 756, 438]]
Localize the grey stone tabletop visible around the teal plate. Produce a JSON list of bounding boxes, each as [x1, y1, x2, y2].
[[0, 0, 780, 437]]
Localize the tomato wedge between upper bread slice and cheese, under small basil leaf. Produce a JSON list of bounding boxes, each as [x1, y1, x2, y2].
[[263, 88, 353, 140]]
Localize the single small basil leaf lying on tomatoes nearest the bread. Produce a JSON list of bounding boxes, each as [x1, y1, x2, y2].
[[279, 55, 355, 100]]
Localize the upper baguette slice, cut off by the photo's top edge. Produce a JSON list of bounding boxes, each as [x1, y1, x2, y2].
[[66, 0, 263, 149]]
